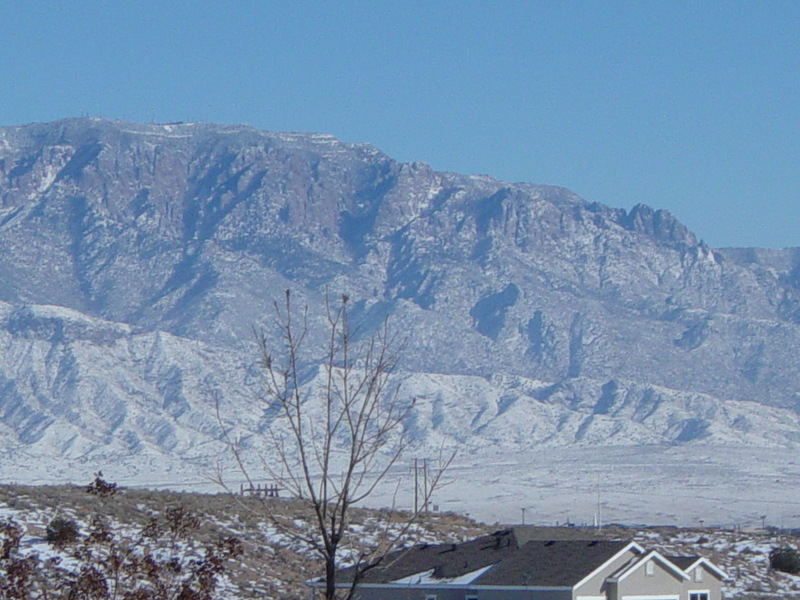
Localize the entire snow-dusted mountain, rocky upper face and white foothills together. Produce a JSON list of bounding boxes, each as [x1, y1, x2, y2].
[[0, 119, 800, 524]]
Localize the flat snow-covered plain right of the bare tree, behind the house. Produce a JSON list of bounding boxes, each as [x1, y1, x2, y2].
[[374, 445, 800, 528]]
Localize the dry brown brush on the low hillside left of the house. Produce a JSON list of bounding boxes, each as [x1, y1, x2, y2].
[[0, 485, 486, 600]]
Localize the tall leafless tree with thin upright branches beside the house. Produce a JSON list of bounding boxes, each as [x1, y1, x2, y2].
[[217, 290, 454, 600]]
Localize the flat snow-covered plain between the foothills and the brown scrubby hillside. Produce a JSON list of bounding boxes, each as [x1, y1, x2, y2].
[[0, 444, 800, 528]]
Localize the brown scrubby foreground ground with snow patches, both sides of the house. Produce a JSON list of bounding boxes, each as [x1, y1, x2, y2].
[[0, 488, 800, 600]]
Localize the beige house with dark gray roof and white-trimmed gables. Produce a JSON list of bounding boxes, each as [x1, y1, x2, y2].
[[310, 529, 726, 600]]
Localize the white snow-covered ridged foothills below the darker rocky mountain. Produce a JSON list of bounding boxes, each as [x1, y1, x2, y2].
[[0, 304, 800, 460]]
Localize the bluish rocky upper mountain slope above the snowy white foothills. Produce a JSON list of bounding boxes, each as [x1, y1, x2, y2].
[[0, 119, 800, 407]]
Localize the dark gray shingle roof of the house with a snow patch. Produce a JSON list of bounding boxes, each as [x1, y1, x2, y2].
[[338, 529, 629, 587]]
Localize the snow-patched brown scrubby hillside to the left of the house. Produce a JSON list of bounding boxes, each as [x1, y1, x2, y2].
[[0, 485, 484, 600]]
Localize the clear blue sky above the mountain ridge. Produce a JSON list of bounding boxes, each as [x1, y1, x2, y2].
[[0, 0, 800, 247]]
